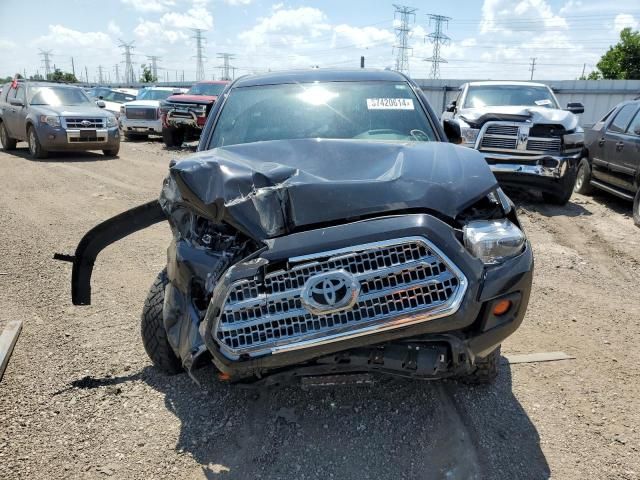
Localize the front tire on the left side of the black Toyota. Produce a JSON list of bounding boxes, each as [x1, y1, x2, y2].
[[140, 269, 182, 375]]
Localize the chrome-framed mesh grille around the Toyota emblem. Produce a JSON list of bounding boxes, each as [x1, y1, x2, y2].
[[213, 237, 466, 356]]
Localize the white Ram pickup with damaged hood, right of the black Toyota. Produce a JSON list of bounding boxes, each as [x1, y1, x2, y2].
[[442, 81, 584, 205]]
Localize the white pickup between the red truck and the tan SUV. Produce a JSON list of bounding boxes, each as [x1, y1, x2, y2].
[[120, 87, 187, 139]]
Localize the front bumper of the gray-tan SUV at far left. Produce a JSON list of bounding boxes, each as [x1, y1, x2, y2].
[[37, 125, 120, 151]]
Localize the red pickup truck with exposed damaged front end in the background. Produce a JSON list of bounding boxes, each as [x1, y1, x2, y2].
[[161, 81, 229, 147]]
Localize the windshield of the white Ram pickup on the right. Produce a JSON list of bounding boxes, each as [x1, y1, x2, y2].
[[464, 85, 558, 108]]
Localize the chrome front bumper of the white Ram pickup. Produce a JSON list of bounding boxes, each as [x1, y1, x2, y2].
[[480, 151, 582, 193]]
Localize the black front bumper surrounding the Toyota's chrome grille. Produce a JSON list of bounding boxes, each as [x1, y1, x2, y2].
[[165, 215, 533, 380]]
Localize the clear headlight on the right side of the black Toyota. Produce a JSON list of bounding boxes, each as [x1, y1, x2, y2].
[[463, 218, 525, 264]]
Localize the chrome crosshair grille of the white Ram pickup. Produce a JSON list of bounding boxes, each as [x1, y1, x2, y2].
[[475, 121, 562, 155]]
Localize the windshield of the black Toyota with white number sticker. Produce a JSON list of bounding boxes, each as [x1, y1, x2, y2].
[[211, 82, 436, 148]]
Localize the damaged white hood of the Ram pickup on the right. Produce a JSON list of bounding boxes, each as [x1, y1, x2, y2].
[[459, 106, 578, 130]]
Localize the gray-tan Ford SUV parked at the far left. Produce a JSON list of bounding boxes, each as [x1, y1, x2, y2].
[[0, 81, 120, 158]]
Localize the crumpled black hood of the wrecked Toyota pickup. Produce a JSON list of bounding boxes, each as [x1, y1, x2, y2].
[[160, 139, 496, 240]]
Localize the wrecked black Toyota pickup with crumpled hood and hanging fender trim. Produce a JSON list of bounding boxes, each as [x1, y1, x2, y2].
[[66, 69, 533, 384]]
